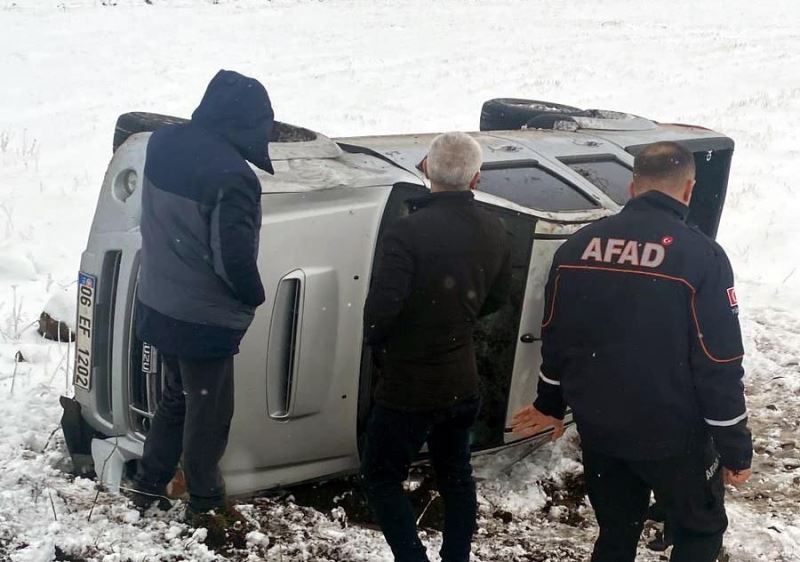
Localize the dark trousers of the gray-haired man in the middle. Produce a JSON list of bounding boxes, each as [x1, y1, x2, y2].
[[361, 399, 479, 562]]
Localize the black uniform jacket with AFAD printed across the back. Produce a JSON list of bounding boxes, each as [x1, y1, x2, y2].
[[536, 192, 752, 469]]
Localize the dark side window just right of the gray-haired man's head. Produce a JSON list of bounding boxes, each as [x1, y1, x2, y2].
[[478, 164, 597, 211]]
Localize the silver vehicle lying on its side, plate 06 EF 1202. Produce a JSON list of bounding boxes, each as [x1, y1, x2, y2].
[[62, 99, 734, 494]]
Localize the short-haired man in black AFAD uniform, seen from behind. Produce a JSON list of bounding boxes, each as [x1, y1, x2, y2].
[[514, 142, 752, 562]]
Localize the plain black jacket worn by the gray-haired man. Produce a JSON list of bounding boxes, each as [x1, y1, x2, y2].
[[364, 192, 511, 411]]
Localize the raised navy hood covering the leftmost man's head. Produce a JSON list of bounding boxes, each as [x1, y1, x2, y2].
[[192, 70, 275, 174]]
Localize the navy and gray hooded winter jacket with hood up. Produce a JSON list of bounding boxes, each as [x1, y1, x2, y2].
[[137, 70, 274, 358]]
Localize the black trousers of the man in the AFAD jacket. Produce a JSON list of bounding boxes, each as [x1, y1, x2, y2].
[[583, 441, 728, 562]]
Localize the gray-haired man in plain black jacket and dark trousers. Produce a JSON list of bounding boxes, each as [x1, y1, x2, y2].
[[361, 133, 511, 562]]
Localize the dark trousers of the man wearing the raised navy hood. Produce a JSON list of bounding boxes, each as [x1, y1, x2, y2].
[[135, 356, 233, 511]]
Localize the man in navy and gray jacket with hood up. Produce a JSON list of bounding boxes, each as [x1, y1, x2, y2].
[[128, 70, 274, 517]]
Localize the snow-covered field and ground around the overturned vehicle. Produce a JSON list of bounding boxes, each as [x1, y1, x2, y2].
[[0, 0, 800, 562]]
